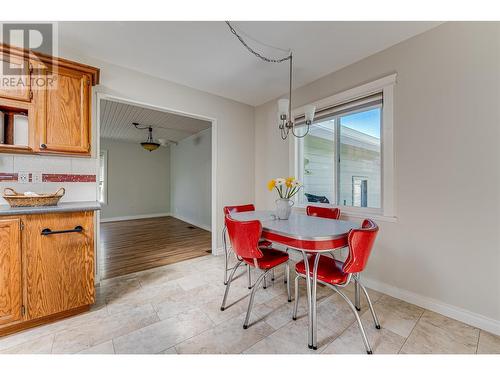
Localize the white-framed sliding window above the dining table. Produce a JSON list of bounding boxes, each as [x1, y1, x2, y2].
[[293, 75, 395, 217]]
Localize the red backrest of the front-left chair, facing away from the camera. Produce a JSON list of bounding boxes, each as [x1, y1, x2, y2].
[[225, 215, 263, 258]]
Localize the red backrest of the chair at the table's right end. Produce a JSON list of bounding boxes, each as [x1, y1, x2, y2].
[[342, 219, 378, 273]]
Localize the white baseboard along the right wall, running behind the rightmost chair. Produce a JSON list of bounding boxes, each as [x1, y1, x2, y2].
[[362, 277, 500, 335]]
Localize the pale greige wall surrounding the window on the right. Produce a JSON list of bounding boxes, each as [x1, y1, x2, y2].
[[255, 22, 500, 334]]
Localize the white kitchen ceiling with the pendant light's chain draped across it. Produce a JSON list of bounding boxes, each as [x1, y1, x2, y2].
[[59, 21, 439, 105]]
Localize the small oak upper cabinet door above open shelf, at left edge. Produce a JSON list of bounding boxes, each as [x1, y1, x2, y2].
[[0, 54, 32, 102]]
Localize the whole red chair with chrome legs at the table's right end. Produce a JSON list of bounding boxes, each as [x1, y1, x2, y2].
[[293, 219, 380, 354]]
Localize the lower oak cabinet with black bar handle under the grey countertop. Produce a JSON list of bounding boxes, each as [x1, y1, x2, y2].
[[0, 211, 95, 335]]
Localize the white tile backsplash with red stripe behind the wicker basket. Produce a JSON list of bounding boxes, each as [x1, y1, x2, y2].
[[0, 154, 98, 205]]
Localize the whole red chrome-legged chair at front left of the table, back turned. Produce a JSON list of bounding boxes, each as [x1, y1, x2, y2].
[[220, 215, 292, 329]]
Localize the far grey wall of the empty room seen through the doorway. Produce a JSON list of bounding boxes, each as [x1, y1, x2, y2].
[[101, 138, 170, 219]]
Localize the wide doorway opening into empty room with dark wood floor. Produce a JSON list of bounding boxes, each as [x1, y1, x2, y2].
[[97, 95, 215, 279]]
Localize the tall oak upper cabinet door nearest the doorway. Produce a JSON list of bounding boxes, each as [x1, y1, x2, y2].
[[39, 68, 91, 154]]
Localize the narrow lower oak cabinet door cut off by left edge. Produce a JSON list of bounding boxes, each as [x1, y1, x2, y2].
[[0, 219, 22, 327]]
